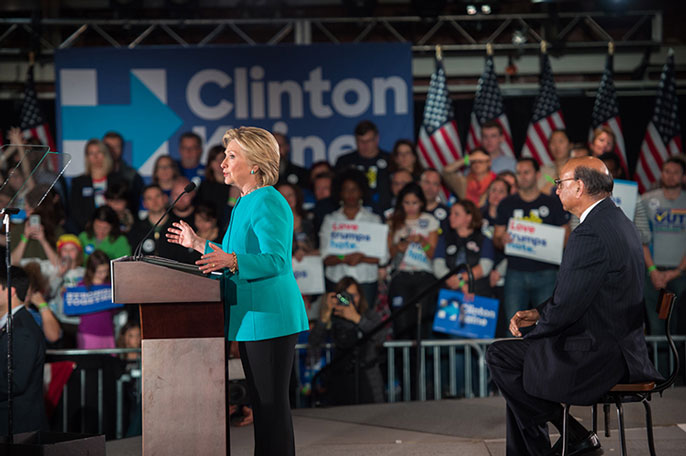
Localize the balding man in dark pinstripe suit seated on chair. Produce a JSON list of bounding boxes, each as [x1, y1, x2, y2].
[[486, 157, 661, 456]]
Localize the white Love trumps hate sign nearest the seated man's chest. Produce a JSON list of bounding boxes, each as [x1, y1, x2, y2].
[[505, 218, 565, 264]]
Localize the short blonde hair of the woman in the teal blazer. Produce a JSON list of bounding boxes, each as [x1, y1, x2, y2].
[[222, 127, 280, 186]]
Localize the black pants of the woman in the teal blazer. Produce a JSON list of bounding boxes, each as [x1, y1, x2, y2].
[[238, 334, 298, 456]]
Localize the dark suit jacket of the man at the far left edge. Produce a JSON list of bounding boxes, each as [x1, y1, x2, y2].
[[0, 308, 47, 435]]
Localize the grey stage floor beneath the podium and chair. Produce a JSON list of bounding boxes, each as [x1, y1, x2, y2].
[[107, 388, 686, 456]]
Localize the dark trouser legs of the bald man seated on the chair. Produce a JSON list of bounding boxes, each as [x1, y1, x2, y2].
[[486, 339, 583, 456]]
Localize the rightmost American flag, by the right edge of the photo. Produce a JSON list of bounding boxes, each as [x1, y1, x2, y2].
[[635, 49, 683, 192]]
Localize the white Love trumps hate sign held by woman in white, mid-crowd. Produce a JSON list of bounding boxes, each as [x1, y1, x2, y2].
[[321, 220, 388, 259]]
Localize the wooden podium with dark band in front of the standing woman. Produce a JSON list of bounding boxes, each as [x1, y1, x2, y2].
[[111, 258, 229, 456]]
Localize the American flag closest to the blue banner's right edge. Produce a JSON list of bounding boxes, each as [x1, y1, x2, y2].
[[417, 59, 462, 170]]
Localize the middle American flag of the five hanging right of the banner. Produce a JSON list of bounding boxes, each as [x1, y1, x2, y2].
[[522, 52, 565, 165]]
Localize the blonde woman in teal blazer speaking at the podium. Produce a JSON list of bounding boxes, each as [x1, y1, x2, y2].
[[167, 127, 308, 456]]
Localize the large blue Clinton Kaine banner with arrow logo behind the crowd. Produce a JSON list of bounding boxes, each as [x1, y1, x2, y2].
[[55, 43, 414, 176]]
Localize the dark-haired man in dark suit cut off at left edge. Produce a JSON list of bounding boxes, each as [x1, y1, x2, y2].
[[0, 262, 47, 435]]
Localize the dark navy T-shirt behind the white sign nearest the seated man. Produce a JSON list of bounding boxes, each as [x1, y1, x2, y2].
[[495, 193, 569, 272]]
